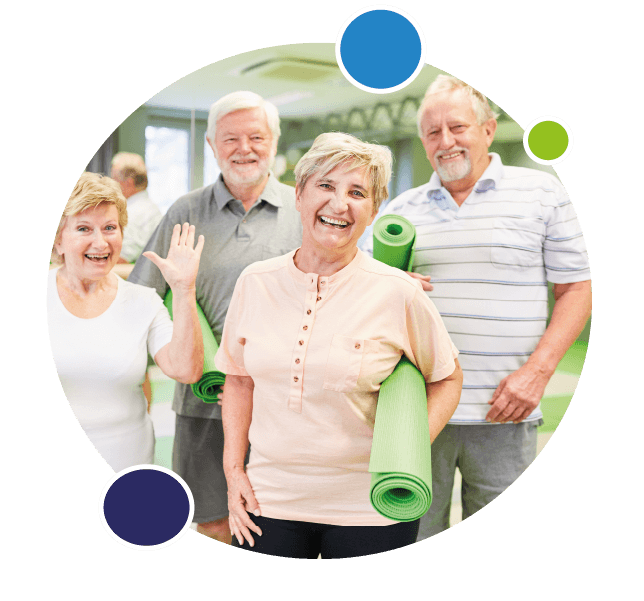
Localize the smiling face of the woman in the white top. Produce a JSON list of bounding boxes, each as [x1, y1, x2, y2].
[[55, 203, 123, 280]]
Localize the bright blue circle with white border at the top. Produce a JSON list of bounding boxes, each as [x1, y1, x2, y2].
[[340, 10, 423, 90]]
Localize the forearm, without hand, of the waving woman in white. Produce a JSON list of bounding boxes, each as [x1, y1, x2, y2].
[[167, 287, 204, 384]]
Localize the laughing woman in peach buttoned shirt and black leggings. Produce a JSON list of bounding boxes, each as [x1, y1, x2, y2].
[[215, 133, 462, 558]]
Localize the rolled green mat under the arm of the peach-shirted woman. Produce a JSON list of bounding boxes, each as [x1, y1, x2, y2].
[[369, 356, 432, 522]]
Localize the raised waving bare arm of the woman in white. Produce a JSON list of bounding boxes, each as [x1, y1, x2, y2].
[[143, 223, 204, 384]]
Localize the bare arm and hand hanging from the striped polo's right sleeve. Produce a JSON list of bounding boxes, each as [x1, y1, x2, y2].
[[486, 280, 592, 424]]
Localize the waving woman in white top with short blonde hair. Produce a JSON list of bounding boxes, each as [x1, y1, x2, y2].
[[47, 173, 204, 471]]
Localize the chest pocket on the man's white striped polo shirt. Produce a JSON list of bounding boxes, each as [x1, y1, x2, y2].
[[490, 217, 546, 270]]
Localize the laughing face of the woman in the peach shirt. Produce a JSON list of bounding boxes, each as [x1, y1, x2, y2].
[[295, 165, 376, 253]]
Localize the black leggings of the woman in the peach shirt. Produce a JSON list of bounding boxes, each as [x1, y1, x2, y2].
[[233, 515, 420, 559]]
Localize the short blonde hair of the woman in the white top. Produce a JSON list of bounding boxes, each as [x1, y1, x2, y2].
[[51, 172, 127, 265]]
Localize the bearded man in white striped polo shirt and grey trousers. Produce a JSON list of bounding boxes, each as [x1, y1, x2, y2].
[[364, 75, 591, 540]]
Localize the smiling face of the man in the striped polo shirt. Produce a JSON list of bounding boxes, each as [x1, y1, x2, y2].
[[420, 90, 496, 188]]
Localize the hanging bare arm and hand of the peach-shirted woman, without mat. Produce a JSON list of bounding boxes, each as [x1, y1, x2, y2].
[[221, 375, 262, 547]]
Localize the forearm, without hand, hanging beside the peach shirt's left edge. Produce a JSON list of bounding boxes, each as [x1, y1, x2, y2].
[[221, 375, 254, 478]]
